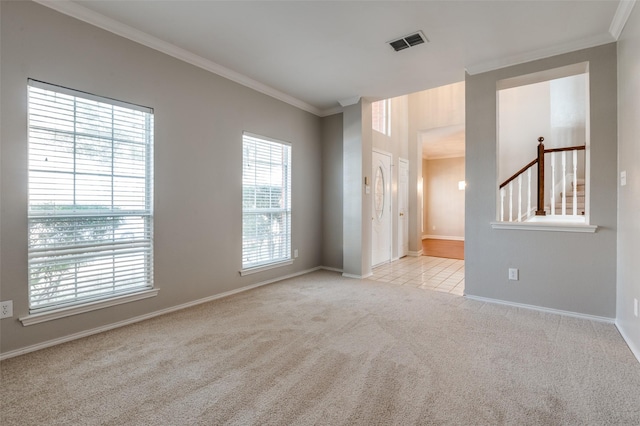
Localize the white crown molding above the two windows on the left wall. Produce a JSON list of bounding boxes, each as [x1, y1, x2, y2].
[[34, 0, 324, 117]]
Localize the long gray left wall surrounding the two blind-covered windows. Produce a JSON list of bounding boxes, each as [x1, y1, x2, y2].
[[0, 2, 323, 352]]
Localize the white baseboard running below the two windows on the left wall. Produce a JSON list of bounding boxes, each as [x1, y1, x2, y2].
[[0, 266, 323, 361]]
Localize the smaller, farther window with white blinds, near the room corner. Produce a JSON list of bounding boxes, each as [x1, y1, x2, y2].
[[242, 133, 291, 272]]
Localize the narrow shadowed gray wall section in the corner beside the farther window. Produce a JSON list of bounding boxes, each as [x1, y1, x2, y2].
[[322, 114, 343, 270]]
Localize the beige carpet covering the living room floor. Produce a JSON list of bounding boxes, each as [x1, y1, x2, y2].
[[0, 272, 640, 426]]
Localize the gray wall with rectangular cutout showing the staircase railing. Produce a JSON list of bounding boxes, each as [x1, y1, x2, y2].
[[465, 43, 616, 318]]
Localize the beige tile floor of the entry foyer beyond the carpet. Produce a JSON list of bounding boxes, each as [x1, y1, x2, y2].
[[369, 256, 464, 296]]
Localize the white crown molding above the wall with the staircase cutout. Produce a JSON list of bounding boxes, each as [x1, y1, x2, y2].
[[466, 33, 616, 75]]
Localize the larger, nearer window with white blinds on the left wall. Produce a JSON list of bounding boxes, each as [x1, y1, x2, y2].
[[28, 80, 153, 313]]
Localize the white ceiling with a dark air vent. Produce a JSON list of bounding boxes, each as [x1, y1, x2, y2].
[[39, 0, 633, 116]]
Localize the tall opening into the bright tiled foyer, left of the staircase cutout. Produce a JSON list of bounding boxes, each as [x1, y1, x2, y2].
[[371, 82, 466, 295]]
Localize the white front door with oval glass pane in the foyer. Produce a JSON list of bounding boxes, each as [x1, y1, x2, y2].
[[371, 151, 391, 266]]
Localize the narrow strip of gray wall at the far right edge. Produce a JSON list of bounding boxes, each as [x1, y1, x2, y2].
[[616, 5, 640, 359]]
